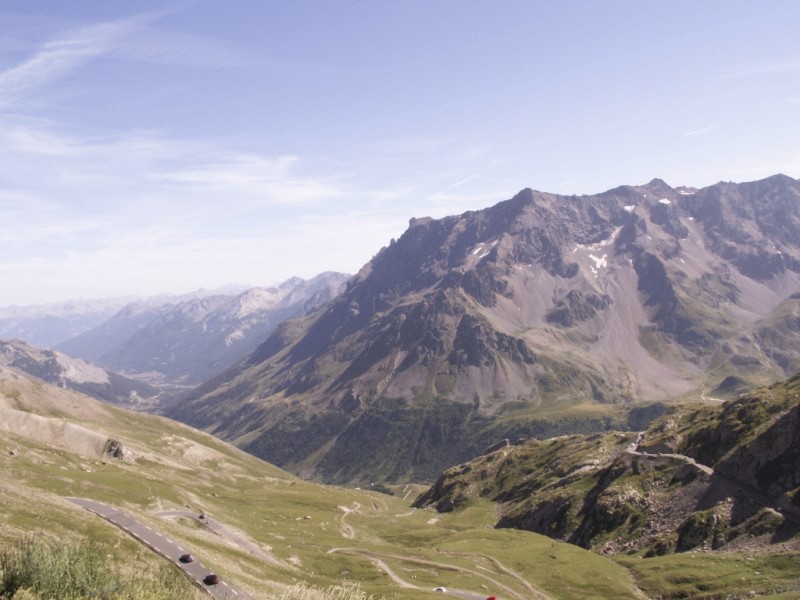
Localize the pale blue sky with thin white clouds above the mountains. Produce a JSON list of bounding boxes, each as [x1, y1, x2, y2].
[[0, 0, 800, 306]]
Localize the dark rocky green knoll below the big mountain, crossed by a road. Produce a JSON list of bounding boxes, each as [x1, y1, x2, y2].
[[414, 375, 800, 555]]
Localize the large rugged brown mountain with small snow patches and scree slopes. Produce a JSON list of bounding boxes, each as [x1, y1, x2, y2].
[[169, 175, 800, 482]]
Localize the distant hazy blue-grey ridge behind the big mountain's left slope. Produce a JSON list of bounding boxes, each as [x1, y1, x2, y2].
[[57, 273, 348, 389]]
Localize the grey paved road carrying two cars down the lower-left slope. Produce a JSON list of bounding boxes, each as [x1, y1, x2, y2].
[[67, 498, 252, 600]]
